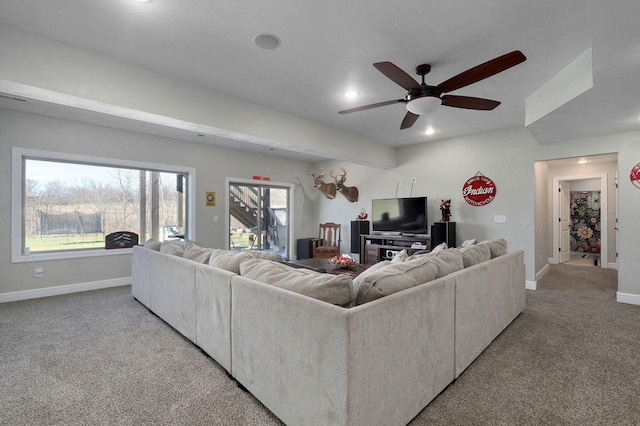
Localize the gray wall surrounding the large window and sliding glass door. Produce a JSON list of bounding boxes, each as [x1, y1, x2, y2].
[[0, 109, 317, 294]]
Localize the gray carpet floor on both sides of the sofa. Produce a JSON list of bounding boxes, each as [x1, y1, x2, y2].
[[0, 265, 640, 425]]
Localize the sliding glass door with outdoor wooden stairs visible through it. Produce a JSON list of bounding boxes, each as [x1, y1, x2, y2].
[[226, 179, 293, 258]]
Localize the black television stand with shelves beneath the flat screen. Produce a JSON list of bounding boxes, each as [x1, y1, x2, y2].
[[360, 235, 431, 265]]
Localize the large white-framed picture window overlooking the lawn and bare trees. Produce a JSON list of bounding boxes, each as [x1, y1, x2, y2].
[[12, 148, 194, 261]]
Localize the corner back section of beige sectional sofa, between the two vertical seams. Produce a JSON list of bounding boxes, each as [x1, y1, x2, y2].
[[231, 276, 455, 425]]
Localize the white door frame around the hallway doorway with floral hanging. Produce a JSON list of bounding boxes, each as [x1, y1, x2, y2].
[[552, 173, 609, 268]]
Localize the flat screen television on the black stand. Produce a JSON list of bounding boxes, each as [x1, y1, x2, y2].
[[371, 197, 428, 235]]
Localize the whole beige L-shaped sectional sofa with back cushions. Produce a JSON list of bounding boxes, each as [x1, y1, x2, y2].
[[132, 238, 525, 425]]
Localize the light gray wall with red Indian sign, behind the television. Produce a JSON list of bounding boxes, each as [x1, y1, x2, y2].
[[316, 127, 640, 303]]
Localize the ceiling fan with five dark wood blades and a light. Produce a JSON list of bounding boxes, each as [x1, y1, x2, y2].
[[339, 50, 527, 129]]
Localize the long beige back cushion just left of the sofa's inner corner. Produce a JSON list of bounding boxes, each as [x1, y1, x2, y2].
[[240, 258, 354, 306]]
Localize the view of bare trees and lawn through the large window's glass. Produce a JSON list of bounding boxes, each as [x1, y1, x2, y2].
[[23, 160, 185, 252]]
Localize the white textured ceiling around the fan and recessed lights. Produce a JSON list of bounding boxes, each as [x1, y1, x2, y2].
[[0, 0, 640, 161]]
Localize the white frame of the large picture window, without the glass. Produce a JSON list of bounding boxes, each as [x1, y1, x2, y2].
[[11, 147, 196, 263]]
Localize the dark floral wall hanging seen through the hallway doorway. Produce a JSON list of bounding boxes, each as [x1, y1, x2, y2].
[[570, 191, 601, 253]]
